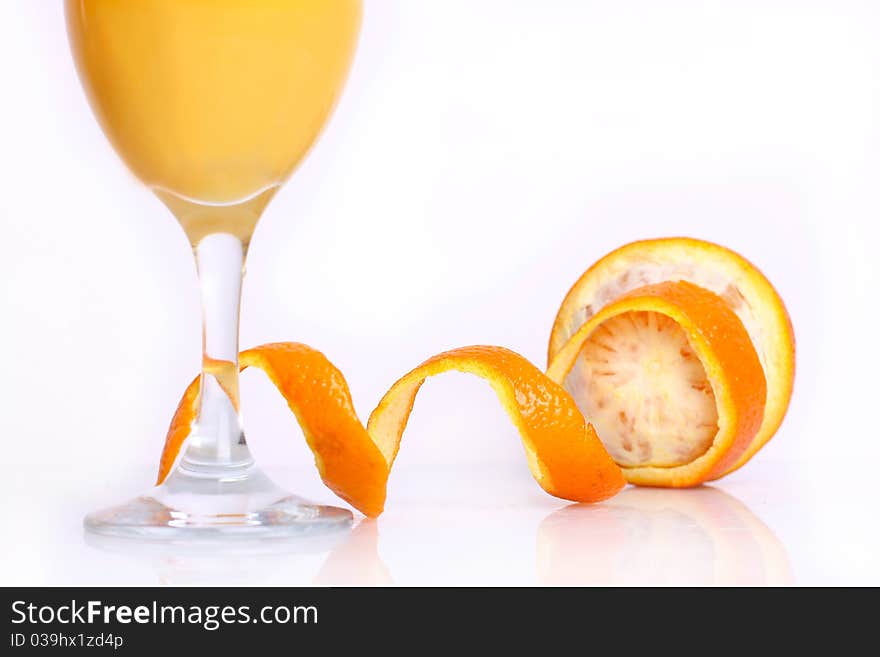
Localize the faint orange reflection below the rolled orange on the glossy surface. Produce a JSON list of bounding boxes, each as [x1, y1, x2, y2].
[[537, 486, 794, 586]]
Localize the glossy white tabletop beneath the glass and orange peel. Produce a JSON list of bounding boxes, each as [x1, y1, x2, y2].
[[0, 464, 880, 586]]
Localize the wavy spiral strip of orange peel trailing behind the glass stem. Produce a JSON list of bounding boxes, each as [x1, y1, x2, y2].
[[158, 342, 626, 516]]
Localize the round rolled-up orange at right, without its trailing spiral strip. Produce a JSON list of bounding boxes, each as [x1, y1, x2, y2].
[[548, 238, 795, 486]]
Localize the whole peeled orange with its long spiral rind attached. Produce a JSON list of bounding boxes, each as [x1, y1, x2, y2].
[[158, 238, 794, 516]]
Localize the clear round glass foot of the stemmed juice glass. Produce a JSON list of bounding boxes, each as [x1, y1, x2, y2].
[[84, 467, 352, 542]]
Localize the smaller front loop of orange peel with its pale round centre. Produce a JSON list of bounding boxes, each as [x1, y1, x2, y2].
[[548, 281, 767, 487]]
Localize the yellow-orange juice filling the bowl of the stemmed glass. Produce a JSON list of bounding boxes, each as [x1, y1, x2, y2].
[[66, 0, 361, 243]]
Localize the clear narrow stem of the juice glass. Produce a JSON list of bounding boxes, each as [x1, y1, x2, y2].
[[180, 233, 253, 477]]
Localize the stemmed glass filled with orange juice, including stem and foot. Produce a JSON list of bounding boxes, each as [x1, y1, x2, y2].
[[65, 0, 361, 540]]
